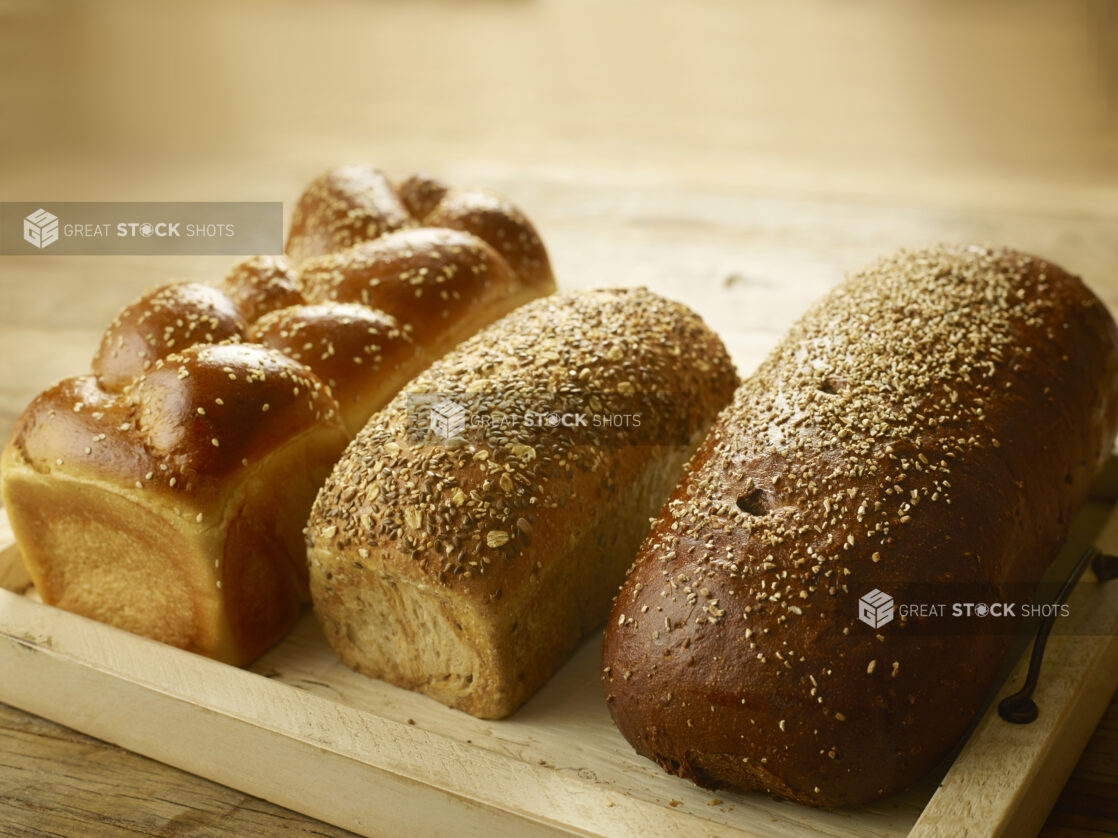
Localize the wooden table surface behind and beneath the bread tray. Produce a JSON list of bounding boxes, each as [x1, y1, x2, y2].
[[0, 0, 1118, 836]]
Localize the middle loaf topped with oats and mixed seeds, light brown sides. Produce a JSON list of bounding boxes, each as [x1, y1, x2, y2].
[[307, 291, 737, 718]]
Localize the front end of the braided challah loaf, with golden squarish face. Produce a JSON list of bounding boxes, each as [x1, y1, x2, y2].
[[0, 343, 348, 665]]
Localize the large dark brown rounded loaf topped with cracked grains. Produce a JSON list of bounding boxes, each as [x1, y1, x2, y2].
[[603, 246, 1118, 808]]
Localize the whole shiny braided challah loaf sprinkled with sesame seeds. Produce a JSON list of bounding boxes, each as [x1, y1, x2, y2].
[[0, 166, 555, 665]]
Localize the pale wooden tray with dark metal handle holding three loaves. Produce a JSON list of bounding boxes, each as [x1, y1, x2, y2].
[[0, 484, 1118, 838]]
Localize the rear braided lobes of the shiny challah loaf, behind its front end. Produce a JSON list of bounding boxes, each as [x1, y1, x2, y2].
[[93, 165, 555, 434]]
